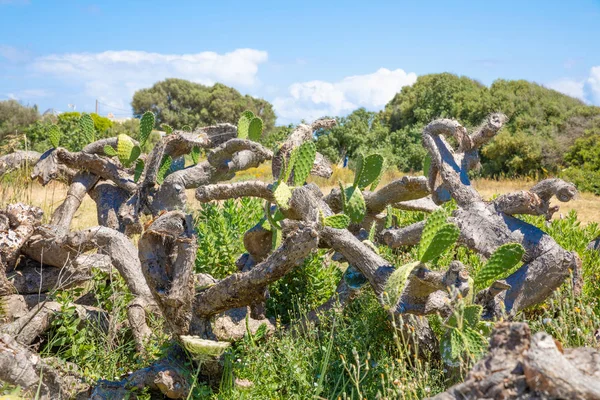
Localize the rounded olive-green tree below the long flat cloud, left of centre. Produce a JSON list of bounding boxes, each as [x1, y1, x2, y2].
[[131, 79, 275, 133]]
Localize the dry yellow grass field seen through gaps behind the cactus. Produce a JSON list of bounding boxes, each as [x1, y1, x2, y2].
[[0, 164, 600, 229]]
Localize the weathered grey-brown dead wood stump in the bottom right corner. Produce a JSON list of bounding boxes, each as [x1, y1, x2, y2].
[[433, 322, 600, 400]]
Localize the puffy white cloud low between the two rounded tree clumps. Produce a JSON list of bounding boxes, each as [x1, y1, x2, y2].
[[273, 68, 417, 123]]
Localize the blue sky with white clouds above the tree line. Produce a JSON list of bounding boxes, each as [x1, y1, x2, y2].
[[0, 0, 600, 123]]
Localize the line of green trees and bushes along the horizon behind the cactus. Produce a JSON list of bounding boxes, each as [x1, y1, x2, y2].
[[0, 73, 600, 194]]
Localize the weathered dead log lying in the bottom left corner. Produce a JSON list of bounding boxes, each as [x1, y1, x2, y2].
[[0, 334, 88, 400]]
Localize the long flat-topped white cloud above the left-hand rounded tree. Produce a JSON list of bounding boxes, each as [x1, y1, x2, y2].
[[30, 49, 268, 113]]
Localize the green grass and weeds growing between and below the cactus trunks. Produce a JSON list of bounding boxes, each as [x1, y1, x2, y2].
[[0, 193, 600, 399]]
